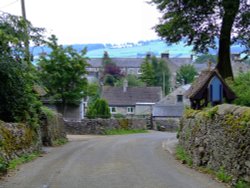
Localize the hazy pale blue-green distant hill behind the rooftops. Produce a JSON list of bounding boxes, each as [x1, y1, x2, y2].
[[31, 40, 245, 58]]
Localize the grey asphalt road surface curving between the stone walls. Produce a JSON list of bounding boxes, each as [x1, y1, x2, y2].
[[0, 132, 227, 188]]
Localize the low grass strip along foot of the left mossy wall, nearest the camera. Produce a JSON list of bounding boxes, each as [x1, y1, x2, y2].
[[8, 152, 40, 169]]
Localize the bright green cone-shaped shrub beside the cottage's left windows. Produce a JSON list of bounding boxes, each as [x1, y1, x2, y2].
[[86, 99, 111, 119]]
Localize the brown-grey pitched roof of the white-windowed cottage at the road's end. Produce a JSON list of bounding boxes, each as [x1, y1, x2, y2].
[[101, 86, 162, 106]]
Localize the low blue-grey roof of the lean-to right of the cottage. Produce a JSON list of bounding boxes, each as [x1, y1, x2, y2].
[[152, 105, 184, 117]]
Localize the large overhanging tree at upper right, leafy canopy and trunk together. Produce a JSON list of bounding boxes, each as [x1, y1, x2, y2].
[[151, 0, 250, 78]]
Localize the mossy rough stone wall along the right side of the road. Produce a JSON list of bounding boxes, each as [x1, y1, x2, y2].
[[179, 104, 250, 182]]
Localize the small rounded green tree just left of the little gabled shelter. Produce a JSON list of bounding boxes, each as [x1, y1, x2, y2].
[[176, 64, 198, 84]]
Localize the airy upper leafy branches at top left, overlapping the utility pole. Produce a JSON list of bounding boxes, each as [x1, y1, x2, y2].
[[0, 13, 44, 64]]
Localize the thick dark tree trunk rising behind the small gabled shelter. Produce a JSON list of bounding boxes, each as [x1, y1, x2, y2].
[[216, 0, 240, 79]]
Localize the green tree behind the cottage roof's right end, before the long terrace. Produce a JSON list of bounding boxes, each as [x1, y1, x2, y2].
[[140, 56, 170, 95]]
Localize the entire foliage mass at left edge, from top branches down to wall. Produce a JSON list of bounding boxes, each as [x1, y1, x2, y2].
[[0, 14, 43, 126]]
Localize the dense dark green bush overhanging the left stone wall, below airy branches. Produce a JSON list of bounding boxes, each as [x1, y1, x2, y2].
[[0, 61, 41, 126]]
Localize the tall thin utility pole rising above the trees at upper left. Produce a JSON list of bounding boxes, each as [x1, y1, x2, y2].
[[21, 0, 30, 65]]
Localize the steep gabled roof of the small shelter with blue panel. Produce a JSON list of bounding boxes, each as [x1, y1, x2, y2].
[[185, 69, 236, 100]]
